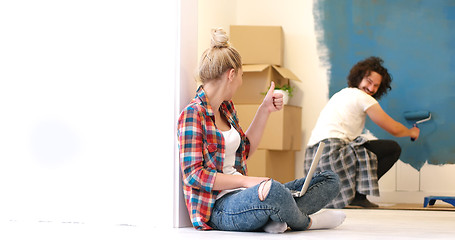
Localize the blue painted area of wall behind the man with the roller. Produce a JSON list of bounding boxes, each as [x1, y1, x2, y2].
[[314, 0, 455, 170]]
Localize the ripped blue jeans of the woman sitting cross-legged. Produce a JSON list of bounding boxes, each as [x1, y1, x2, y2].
[[208, 171, 340, 231]]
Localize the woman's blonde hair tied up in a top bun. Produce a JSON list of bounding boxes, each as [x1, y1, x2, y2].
[[198, 28, 242, 84]]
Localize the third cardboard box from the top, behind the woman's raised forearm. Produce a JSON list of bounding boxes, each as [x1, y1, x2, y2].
[[235, 104, 302, 150]]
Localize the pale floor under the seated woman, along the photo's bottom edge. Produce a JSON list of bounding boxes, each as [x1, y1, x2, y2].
[[0, 209, 455, 240]]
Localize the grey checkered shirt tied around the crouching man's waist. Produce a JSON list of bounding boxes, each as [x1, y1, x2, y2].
[[304, 136, 379, 208]]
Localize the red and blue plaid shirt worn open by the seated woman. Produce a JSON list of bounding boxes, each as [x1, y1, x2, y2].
[[177, 86, 250, 230]]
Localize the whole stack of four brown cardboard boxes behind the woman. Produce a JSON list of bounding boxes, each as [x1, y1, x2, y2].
[[230, 25, 302, 183]]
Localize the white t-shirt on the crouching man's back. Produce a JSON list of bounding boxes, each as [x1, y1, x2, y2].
[[308, 87, 378, 146]]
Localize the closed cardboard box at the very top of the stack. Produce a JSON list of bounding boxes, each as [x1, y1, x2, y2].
[[229, 25, 284, 66]]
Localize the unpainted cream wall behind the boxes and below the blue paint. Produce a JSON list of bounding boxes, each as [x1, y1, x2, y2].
[[198, 0, 455, 203]]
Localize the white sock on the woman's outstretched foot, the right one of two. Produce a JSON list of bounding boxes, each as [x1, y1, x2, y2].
[[309, 210, 346, 229]]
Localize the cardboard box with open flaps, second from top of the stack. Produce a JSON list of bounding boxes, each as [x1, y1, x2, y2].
[[232, 64, 300, 104]]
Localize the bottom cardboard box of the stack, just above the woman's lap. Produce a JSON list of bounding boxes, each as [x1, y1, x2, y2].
[[247, 150, 295, 183]]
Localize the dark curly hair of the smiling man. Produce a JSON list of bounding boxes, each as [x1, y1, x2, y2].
[[347, 57, 392, 100]]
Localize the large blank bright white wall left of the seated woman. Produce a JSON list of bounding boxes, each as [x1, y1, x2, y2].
[[0, 0, 179, 227]]
